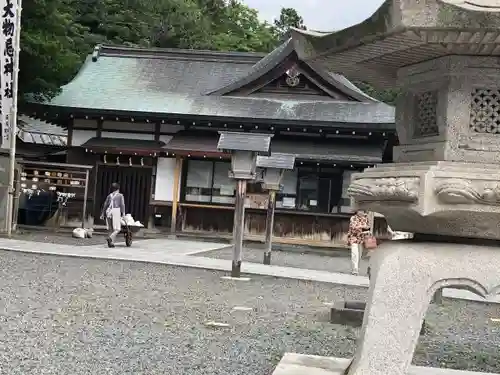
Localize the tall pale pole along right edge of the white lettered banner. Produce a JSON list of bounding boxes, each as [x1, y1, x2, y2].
[[2, 0, 22, 237]]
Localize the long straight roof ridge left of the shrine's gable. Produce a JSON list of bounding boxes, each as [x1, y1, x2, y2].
[[92, 44, 267, 62]]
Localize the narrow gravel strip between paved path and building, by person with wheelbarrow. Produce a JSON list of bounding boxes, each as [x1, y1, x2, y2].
[[4, 231, 151, 246]]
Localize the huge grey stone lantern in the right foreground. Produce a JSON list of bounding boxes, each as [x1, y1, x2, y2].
[[292, 0, 500, 375]]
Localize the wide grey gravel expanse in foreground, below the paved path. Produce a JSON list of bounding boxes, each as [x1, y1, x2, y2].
[[0, 251, 500, 375]]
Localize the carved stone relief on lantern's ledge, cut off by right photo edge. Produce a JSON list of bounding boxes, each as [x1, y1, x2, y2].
[[434, 179, 500, 205]]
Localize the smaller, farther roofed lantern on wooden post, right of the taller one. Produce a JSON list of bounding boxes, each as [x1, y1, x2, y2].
[[257, 152, 295, 264]]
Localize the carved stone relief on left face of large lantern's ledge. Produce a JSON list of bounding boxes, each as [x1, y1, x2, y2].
[[347, 177, 420, 202]]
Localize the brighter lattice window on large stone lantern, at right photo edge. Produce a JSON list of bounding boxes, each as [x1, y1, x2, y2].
[[469, 89, 500, 134]]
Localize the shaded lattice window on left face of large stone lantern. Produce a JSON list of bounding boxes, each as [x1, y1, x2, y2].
[[413, 91, 439, 137]]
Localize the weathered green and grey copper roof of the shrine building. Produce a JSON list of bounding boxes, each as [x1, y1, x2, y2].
[[31, 47, 394, 129]]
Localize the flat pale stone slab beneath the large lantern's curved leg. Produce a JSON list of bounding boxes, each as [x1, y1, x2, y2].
[[272, 353, 500, 375]]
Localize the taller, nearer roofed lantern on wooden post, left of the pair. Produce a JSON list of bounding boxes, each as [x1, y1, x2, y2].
[[217, 132, 272, 277]]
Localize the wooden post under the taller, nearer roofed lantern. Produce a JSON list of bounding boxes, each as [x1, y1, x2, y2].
[[231, 180, 247, 277]]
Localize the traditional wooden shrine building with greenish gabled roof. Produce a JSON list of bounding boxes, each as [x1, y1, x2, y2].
[[26, 39, 397, 246]]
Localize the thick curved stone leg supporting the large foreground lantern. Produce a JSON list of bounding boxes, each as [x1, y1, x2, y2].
[[345, 241, 500, 375]]
